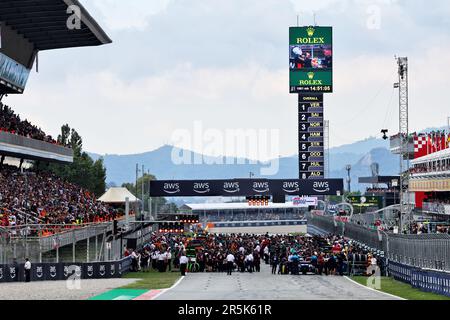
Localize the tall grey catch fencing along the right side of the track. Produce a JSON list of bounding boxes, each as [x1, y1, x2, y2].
[[308, 214, 450, 272]]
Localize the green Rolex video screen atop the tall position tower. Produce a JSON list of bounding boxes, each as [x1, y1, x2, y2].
[[289, 27, 333, 93]]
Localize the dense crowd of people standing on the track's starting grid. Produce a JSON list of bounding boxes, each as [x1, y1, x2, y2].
[[125, 234, 383, 276]]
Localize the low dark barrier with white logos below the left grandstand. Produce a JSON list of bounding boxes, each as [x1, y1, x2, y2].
[[0, 257, 131, 283]]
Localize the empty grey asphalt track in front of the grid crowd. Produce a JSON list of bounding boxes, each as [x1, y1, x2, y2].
[[157, 265, 395, 300]]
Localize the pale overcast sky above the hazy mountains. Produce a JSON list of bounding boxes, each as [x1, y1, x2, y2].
[[5, 0, 450, 160]]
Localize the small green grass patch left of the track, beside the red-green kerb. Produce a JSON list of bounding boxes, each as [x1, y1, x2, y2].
[[121, 271, 180, 290]]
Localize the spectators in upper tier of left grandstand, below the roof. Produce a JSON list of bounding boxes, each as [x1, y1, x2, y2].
[[0, 102, 57, 144]]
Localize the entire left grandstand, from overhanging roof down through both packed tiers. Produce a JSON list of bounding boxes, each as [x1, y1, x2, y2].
[[0, 0, 119, 260]]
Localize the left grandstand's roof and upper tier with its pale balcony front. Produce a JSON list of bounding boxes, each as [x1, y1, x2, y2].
[[0, 0, 111, 163]]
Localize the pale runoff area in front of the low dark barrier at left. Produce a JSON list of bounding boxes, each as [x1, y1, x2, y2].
[[0, 279, 136, 300]]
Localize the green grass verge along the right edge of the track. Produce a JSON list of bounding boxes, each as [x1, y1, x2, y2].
[[351, 277, 450, 300]]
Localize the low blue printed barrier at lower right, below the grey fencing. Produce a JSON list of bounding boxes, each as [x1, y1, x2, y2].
[[388, 262, 450, 297]]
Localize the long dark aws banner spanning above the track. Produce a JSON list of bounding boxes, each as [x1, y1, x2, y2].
[[150, 179, 344, 197]]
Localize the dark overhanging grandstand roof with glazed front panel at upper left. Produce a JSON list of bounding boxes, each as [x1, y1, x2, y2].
[[0, 0, 112, 94]]
